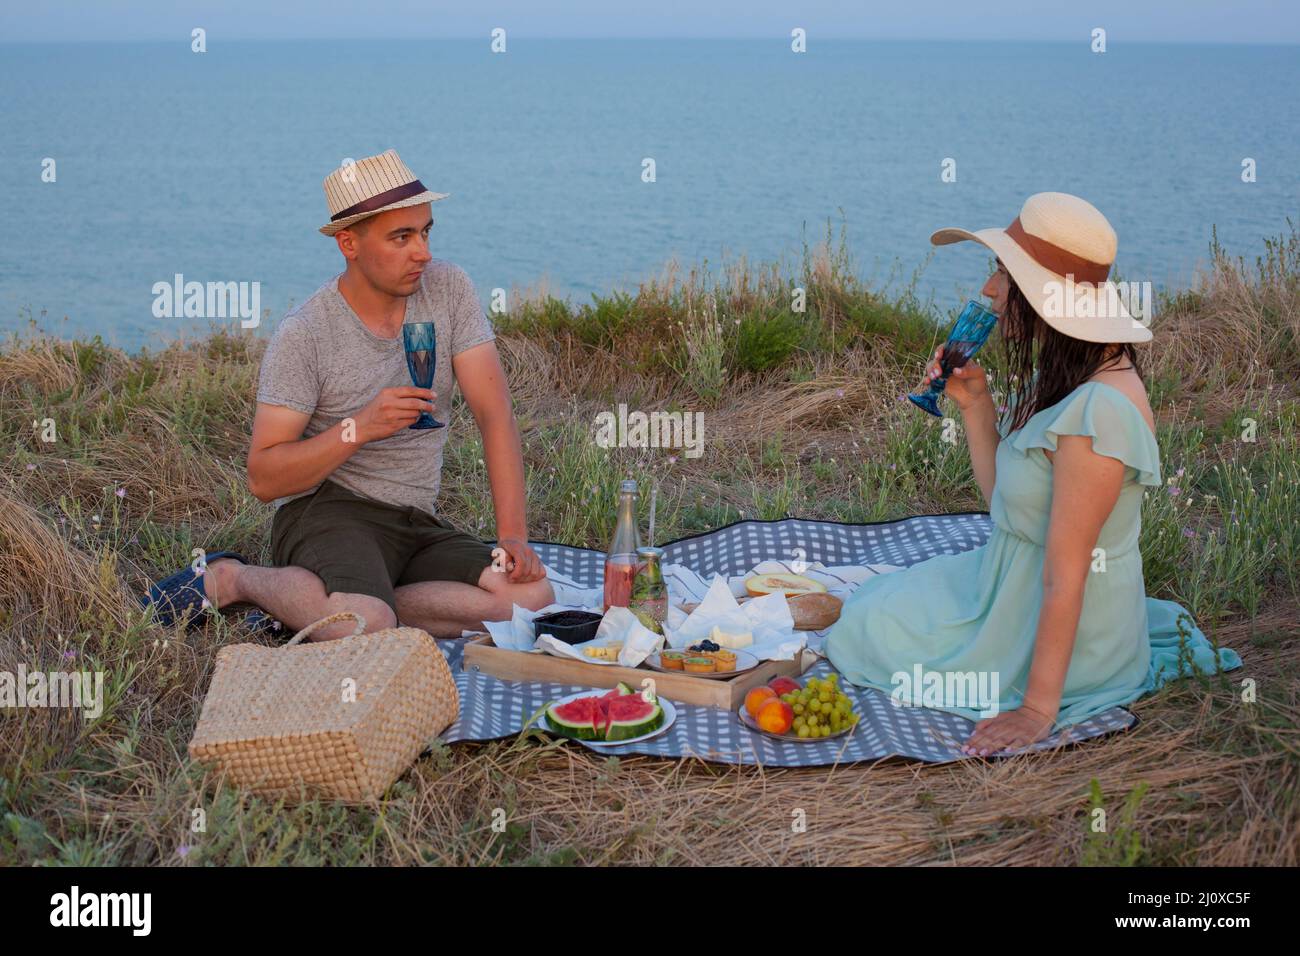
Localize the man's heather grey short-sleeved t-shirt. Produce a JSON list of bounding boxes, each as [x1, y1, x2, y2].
[[257, 259, 494, 514]]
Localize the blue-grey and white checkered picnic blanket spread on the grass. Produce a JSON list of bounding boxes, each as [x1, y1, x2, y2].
[[438, 512, 1138, 767]]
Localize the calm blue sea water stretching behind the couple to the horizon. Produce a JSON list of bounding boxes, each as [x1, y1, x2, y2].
[[0, 36, 1300, 349]]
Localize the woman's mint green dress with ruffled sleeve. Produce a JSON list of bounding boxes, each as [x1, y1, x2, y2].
[[824, 381, 1242, 730]]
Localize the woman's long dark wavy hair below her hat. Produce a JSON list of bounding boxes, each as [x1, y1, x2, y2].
[[1002, 277, 1143, 433]]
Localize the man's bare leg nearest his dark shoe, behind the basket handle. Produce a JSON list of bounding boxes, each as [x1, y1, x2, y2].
[[203, 558, 397, 641]]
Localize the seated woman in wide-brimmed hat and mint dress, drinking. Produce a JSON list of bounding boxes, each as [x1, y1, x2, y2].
[[826, 193, 1240, 754]]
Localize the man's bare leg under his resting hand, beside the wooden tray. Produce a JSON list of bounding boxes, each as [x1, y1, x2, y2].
[[397, 566, 555, 637]]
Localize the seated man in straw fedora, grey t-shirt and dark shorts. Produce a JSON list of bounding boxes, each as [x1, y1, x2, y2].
[[144, 150, 554, 640]]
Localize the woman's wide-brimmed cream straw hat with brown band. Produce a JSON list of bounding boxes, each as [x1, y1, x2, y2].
[[930, 193, 1152, 342]]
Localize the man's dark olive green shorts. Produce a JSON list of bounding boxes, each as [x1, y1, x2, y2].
[[270, 480, 491, 614]]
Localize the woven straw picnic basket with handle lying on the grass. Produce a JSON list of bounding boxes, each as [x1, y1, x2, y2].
[[190, 611, 460, 803]]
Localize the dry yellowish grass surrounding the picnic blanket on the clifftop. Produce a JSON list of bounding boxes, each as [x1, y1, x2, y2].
[[0, 230, 1300, 865]]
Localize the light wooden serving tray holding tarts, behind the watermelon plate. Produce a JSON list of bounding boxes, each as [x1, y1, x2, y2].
[[460, 633, 818, 711]]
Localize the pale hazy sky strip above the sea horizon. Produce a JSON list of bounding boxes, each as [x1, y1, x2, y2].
[[0, 0, 1300, 44]]
